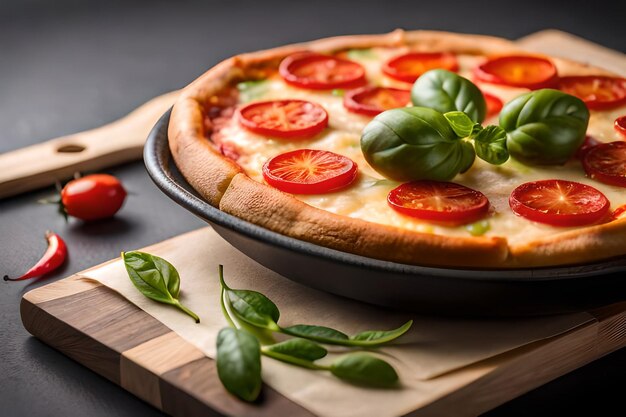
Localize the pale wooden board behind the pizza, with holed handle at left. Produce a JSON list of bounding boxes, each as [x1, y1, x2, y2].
[[0, 30, 626, 199]]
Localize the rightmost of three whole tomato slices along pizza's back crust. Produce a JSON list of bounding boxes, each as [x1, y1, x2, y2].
[[474, 55, 558, 90]]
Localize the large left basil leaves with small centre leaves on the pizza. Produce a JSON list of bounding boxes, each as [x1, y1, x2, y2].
[[361, 107, 509, 181]]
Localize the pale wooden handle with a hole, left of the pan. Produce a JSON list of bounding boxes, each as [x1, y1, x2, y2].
[[0, 91, 179, 198]]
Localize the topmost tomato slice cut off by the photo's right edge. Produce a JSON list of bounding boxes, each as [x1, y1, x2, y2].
[[559, 75, 626, 110]]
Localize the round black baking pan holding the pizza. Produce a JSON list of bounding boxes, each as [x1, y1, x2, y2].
[[144, 112, 626, 316]]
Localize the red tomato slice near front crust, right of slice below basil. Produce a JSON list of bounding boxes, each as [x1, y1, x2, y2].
[[509, 180, 609, 227]]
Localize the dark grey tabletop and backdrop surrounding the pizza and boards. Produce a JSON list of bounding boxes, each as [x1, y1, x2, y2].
[[0, 0, 626, 417]]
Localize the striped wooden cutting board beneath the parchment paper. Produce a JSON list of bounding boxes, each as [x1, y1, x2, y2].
[[20, 228, 626, 417]]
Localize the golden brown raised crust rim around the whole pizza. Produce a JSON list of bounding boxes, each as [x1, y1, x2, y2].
[[169, 30, 626, 268]]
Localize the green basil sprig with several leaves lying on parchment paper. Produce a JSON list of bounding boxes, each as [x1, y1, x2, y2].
[[217, 265, 412, 401]]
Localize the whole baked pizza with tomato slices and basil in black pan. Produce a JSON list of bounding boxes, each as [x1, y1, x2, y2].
[[168, 31, 626, 269]]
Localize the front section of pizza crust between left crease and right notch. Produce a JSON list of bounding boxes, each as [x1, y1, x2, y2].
[[219, 174, 508, 267]]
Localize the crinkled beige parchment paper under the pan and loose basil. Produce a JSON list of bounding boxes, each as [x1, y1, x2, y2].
[[83, 228, 593, 417]]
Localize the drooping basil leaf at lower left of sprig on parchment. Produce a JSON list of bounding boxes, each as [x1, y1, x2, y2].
[[217, 327, 263, 401]]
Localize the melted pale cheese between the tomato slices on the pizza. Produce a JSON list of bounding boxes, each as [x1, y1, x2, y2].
[[222, 48, 626, 244]]
